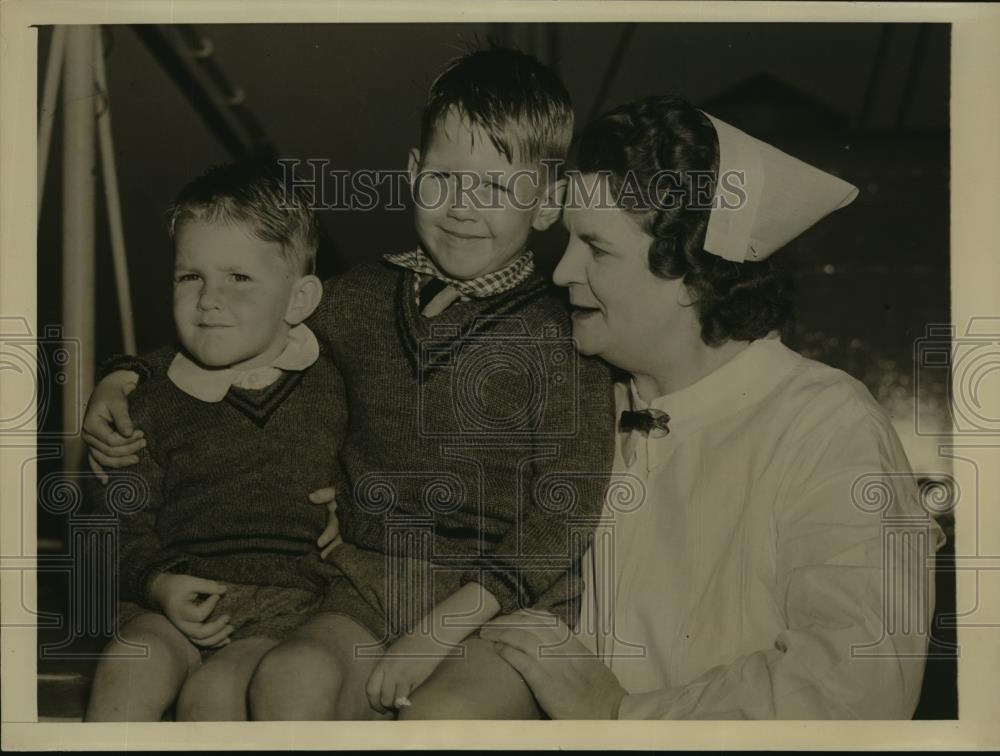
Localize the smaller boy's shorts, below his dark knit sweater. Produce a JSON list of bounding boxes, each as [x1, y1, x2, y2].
[[117, 582, 327, 656]]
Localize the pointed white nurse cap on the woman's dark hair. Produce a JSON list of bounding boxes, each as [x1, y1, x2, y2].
[[702, 111, 858, 262]]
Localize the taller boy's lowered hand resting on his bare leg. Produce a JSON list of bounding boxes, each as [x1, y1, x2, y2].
[[365, 634, 456, 714]]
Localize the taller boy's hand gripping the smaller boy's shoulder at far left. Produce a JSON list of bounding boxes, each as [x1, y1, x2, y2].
[[82, 370, 146, 483]]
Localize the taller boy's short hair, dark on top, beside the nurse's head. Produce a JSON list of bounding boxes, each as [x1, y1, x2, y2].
[[420, 45, 573, 174]]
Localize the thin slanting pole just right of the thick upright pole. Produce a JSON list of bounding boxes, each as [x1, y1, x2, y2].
[[94, 33, 136, 354]]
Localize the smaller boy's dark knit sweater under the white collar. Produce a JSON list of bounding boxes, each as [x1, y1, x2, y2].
[[105, 352, 345, 605]]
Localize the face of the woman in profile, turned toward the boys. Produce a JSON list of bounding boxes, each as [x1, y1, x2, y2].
[[552, 174, 683, 373]]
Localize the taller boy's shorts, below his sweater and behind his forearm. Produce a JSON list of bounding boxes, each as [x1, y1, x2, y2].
[[308, 543, 582, 646]]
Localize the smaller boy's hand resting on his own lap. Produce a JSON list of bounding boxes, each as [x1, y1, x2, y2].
[[149, 572, 235, 648]]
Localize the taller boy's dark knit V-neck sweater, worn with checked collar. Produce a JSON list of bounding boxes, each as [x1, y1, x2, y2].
[[113, 262, 615, 613]]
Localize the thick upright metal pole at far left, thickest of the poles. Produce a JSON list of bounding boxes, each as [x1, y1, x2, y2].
[[62, 26, 96, 467]]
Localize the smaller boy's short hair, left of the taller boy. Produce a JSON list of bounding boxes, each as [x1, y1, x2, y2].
[[169, 160, 319, 275]]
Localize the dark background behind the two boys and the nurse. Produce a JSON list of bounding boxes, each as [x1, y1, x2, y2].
[[38, 23, 957, 717]]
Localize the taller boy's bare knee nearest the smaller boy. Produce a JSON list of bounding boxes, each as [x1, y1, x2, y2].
[[250, 614, 386, 721]]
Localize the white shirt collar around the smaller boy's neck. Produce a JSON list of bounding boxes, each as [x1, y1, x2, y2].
[[167, 323, 319, 402]]
